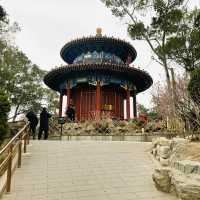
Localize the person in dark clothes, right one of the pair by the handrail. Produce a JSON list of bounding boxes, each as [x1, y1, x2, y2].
[[38, 108, 51, 140]]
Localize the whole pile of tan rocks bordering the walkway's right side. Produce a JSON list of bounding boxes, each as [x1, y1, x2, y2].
[[151, 138, 200, 200]]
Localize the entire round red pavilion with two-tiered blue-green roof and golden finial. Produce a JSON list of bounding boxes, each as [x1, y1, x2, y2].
[[44, 29, 153, 121]]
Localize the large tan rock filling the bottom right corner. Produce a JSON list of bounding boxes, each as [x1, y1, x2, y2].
[[171, 170, 200, 200]]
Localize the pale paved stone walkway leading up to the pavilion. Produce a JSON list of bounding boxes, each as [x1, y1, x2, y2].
[[3, 141, 176, 200]]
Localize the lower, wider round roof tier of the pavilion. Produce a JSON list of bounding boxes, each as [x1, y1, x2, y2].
[[44, 63, 153, 93]]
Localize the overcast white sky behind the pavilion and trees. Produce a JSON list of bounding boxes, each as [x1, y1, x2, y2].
[[0, 0, 200, 107]]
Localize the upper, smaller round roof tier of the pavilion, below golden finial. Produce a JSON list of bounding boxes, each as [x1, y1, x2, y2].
[[60, 36, 137, 64]]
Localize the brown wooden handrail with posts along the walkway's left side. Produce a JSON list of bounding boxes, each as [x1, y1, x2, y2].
[[0, 123, 29, 197]]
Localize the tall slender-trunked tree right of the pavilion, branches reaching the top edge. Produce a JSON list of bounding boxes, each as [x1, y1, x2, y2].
[[101, 0, 187, 116]]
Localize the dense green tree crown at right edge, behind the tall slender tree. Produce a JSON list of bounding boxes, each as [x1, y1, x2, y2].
[[165, 9, 200, 73]]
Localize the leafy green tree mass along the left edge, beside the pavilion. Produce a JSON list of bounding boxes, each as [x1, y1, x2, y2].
[[0, 6, 57, 121]]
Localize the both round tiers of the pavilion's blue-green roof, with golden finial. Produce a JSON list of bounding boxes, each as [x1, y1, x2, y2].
[[44, 29, 153, 93]]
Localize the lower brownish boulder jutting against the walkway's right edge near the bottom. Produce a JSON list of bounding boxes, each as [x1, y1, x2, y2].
[[152, 168, 171, 193]]
